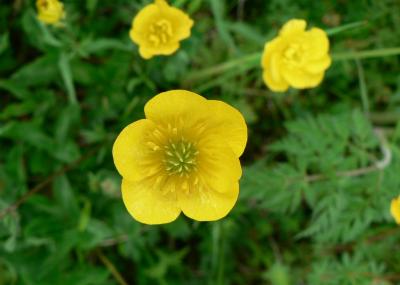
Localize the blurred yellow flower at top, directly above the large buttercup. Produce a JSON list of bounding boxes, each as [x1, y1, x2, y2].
[[129, 0, 193, 59]]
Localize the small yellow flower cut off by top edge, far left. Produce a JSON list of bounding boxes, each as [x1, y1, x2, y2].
[[36, 0, 65, 24]]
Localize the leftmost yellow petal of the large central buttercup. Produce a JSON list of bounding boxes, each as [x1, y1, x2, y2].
[[112, 119, 154, 181]]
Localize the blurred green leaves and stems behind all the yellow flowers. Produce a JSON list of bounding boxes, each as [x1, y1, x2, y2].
[[0, 0, 400, 285]]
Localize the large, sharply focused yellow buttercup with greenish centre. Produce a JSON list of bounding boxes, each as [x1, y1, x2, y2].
[[113, 90, 247, 224]]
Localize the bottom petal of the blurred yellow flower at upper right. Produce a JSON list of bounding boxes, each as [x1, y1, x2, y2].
[[281, 66, 324, 89]]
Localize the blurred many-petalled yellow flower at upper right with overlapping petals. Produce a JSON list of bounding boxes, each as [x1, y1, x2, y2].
[[261, 19, 331, 92]]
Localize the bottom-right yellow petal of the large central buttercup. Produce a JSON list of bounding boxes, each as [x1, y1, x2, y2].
[[178, 182, 239, 221]]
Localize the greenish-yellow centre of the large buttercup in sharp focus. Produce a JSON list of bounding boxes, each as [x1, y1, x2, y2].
[[164, 139, 199, 176]]
